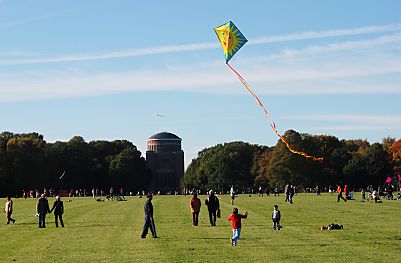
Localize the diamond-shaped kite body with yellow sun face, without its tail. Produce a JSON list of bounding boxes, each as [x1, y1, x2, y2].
[[214, 21, 248, 62]]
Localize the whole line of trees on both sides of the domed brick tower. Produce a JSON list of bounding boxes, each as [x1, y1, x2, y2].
[[0, 130, 401, 196]]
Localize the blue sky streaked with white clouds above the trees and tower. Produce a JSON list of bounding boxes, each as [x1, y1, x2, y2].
[[0, 0, 401, 166]]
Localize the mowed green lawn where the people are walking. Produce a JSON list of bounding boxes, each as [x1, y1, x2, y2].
[[0, 194, 401, 262]]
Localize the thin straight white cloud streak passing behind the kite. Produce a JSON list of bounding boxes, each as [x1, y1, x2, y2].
[[0, 24, 401, 65]]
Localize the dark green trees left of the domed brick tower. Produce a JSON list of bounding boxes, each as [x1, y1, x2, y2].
[[0, 132, 152, 196]]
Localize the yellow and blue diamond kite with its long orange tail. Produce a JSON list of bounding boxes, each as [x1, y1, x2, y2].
[[214, 21, 323, 162]]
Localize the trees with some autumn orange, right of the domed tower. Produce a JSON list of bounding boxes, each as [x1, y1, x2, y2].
[[182, 130, 401, 194]]
